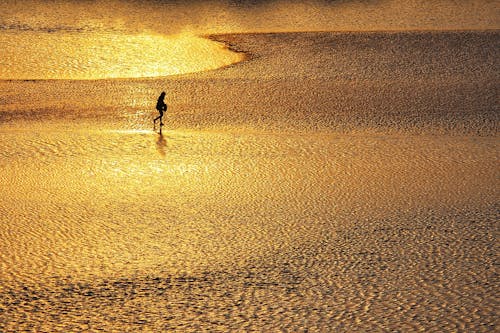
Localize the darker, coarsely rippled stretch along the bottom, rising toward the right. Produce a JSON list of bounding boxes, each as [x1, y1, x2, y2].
[[0, 209, 499, 332]]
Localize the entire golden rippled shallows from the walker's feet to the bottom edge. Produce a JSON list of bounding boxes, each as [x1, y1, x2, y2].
[[0, 125, 498, 331]]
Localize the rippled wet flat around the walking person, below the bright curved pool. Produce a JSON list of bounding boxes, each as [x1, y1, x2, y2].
[[0, 31, 500, 332]]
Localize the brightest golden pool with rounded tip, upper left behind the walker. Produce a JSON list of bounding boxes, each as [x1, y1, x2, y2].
[[0, 31, 242, 80]]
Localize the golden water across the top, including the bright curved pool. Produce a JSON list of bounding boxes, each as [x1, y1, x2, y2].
[[0, 0, 498, 80]]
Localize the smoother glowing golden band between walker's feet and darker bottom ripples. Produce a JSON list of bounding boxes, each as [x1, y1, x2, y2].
[[0, 124, 498, 280]]
